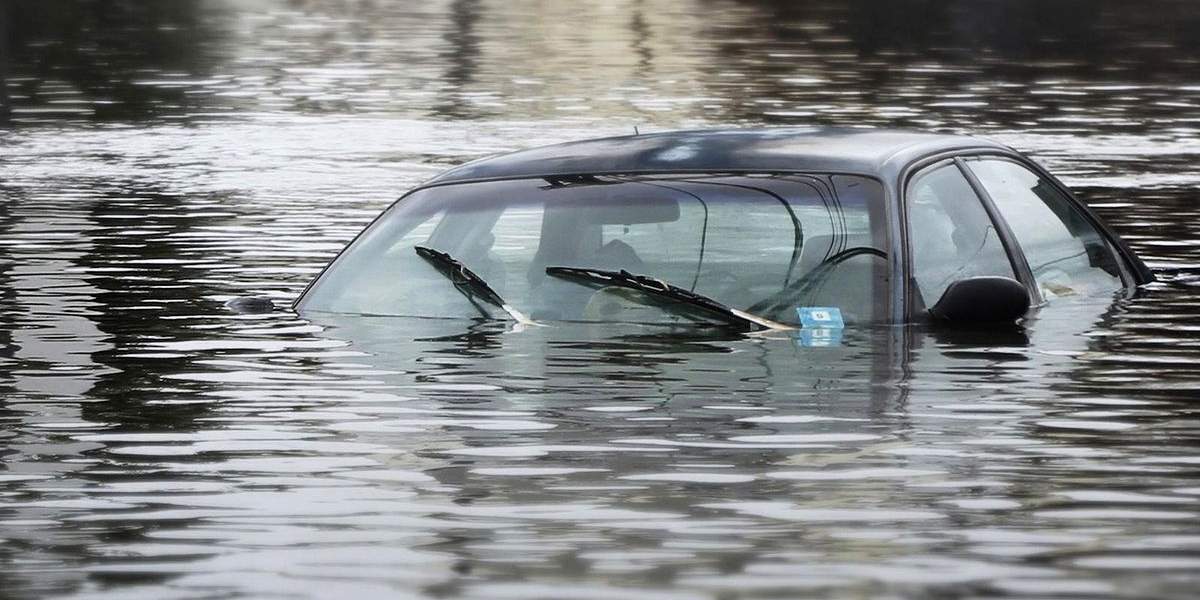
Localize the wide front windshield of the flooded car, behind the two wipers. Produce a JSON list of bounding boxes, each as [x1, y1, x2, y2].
[[298, 175, 888, 324]]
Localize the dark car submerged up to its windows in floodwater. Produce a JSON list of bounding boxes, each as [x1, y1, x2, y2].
[[294, 128, 1153, 331]]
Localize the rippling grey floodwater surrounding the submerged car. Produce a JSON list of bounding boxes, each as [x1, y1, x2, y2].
[[0, 0, 1200, 600]]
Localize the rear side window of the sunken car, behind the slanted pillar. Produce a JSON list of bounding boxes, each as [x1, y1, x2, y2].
[[967, 158, 1122, 299]]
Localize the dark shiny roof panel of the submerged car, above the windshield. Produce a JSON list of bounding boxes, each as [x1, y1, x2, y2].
[[425, 127, 1009, 185]]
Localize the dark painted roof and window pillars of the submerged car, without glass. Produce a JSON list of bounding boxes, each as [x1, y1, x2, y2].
[[295, 128, 1153, 323]]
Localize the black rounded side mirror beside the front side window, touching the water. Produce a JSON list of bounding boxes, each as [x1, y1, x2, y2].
[[929, 277, 1030, 323]]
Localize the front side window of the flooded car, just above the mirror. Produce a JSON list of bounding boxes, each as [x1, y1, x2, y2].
[[906, 162, 1015, 306]]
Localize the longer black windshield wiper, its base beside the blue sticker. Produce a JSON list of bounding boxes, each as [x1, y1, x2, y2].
[[546, 266, 794, 330]]
